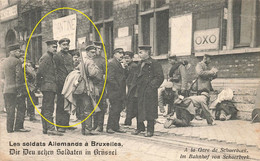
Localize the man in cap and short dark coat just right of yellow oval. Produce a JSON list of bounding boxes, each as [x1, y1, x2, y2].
[[107, 48, 126, 133]]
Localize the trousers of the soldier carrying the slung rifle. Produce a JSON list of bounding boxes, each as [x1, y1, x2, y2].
[[75, 94, 93, 130]]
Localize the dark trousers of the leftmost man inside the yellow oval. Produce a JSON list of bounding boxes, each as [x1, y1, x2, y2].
[[41, 91, 55, 133]]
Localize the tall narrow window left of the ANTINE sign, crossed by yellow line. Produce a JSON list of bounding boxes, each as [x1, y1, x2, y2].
[[22, 8, 42, 64]]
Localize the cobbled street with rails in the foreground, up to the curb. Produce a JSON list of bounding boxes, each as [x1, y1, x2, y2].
[[0, 114, 260, 161]]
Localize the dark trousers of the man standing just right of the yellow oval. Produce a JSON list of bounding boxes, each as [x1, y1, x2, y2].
[[107, 99, 124, 131]]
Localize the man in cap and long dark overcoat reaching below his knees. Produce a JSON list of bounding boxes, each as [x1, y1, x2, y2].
[[132, 45, 164, 137]]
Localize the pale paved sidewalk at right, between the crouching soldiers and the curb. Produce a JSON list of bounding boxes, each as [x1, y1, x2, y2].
[[116, 114, 260, 150]]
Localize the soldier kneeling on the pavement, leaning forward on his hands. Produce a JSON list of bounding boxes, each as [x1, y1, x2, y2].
[[164, 92, 214, 128]]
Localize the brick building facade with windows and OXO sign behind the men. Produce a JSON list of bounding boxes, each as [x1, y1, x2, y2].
[[0, 0, 260, 119]]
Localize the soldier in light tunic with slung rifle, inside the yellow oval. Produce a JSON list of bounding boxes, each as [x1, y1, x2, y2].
[[74, 45, 102, 135]]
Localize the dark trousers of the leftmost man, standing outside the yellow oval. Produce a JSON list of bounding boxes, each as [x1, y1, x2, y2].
[[4, 93, 26, 132]]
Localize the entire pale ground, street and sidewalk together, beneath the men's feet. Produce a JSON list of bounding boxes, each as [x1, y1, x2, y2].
[[0, 113, 260, 161]]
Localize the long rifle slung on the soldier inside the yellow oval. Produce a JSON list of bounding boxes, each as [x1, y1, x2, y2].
[[79, 48, 101, 112]]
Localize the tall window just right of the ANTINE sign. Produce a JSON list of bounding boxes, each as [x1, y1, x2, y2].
[[92, 0, 114, 58]]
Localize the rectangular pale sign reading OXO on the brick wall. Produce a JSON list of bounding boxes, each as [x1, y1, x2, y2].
[[193, 28, 219, 51]]
